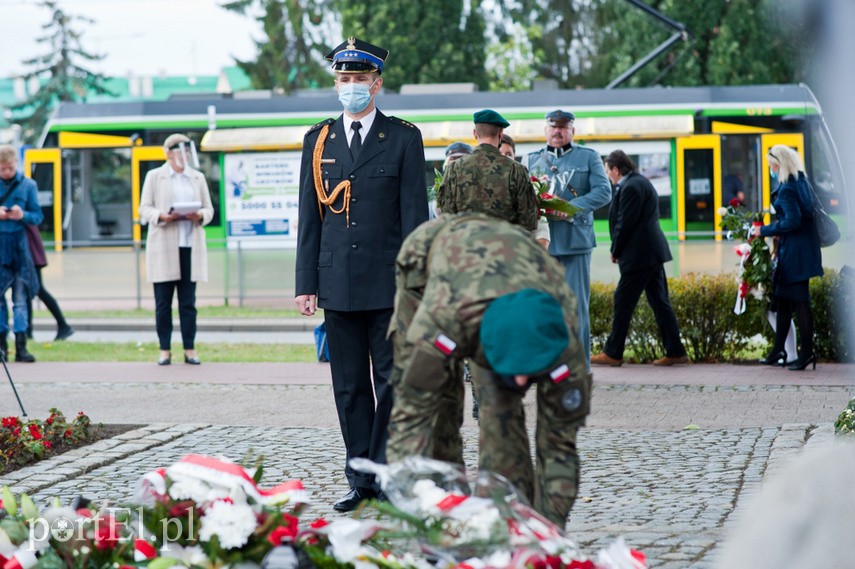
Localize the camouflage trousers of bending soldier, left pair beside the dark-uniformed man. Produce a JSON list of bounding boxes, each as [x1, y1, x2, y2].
[[386, 358, 465, 465]]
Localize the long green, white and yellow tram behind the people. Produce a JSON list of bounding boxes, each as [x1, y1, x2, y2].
[[24, 84, 848, 250]]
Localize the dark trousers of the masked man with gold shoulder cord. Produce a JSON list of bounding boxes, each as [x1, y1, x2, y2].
[[324, 308, 392, 489]]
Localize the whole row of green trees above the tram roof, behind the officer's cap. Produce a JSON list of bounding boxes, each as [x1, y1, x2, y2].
[[224, 0, 802, 92]]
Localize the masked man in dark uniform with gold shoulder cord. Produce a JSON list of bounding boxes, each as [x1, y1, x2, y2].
[[295, 38, 428, 512]]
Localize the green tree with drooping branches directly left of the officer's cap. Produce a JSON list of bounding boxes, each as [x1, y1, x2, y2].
[[222, 0, 330, 93]]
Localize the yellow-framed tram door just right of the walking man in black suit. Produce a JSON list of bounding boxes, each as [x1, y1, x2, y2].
[[677, 134, 721, 241]]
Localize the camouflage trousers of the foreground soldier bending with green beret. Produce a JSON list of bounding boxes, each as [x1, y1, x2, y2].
[[470, 362, 591, 529]]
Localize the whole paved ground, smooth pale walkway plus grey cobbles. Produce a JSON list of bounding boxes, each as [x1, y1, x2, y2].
[[0, 365, 855, 569]]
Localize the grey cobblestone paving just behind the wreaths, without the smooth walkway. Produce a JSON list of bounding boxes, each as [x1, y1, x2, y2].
[[0, 418, 848, 569]]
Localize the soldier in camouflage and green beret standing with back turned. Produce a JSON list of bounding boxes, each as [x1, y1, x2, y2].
[[437, 109, 538, 230]]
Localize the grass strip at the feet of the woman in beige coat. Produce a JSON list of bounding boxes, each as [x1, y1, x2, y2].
[[29, 342, 317, 363]]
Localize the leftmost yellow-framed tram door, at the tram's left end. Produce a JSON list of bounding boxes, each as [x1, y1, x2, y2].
[[24, 148, 62, 251]]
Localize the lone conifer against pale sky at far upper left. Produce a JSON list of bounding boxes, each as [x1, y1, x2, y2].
[[10, 0, 113, 143]]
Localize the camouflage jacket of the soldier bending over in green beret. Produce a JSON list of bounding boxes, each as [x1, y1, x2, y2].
[[390, 214, 587, 377]]
